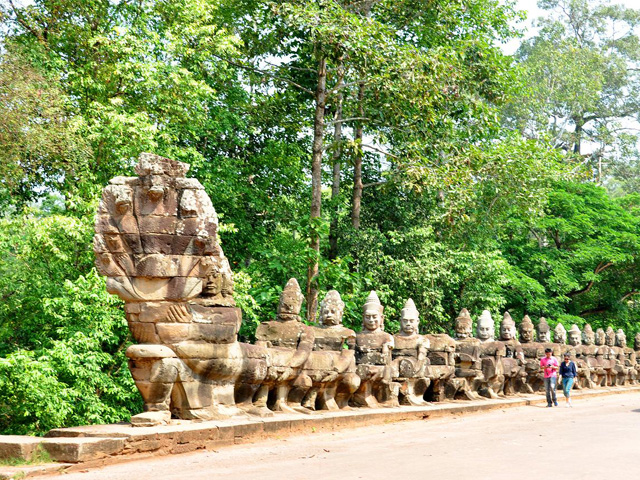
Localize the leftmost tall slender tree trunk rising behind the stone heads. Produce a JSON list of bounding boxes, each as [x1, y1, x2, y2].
[[306, 56, 327, 322]]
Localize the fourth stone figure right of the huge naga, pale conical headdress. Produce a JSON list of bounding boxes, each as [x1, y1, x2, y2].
[[392, 299, 430, 405]]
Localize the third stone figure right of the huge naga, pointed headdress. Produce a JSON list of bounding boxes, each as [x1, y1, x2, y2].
[[352, 291, 394, 408]]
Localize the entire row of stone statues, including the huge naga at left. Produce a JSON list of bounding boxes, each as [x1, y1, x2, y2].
[[94, 154, 638, 425]]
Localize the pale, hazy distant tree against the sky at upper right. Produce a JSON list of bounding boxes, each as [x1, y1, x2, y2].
[[507, 0, 640, 187]]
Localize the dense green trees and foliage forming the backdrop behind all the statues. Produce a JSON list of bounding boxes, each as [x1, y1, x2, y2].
[[0, 0, 640, 434]]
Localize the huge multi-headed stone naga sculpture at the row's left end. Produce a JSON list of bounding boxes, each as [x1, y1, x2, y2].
[[94, 154, 242, 425]]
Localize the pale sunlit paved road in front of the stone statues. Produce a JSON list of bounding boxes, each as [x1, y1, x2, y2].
[[39, 393, 640, 480]]
